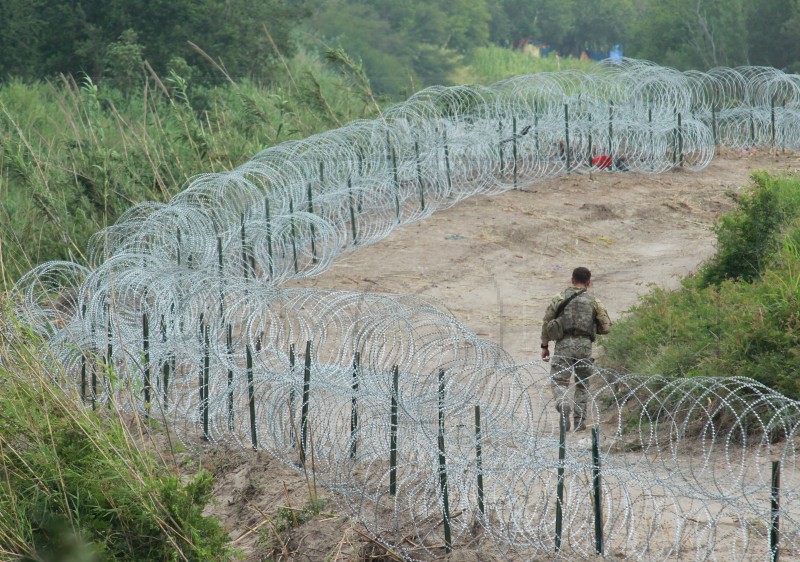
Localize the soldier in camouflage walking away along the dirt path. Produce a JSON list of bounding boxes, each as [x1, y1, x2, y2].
[[541, 267, 611, 431]]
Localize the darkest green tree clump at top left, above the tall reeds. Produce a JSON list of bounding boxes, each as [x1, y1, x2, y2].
[[0, 0, 308, 84]]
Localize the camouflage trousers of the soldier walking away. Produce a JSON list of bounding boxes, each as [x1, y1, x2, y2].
[[550, 337, 594, 418]]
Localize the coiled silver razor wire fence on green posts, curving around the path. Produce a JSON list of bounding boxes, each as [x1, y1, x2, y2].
[[10, 60, 800, 560]]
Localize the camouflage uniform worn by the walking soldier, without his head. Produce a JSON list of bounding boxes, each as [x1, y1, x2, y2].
[[542, 287, 611, 420]]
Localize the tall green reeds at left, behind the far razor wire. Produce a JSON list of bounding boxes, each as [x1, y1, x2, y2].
[[0, 49, 378, 288]]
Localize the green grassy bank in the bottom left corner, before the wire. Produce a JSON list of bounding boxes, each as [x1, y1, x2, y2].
[[0, 302, 232, 562]]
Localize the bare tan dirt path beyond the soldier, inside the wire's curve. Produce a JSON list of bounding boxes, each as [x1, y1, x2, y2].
[[288, 147, 800, 363]]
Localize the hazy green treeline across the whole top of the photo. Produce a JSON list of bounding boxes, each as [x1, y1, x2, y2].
[[0, 0, 800, 96]]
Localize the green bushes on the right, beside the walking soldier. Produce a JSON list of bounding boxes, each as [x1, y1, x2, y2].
[[604, 173, 800, 399]]
